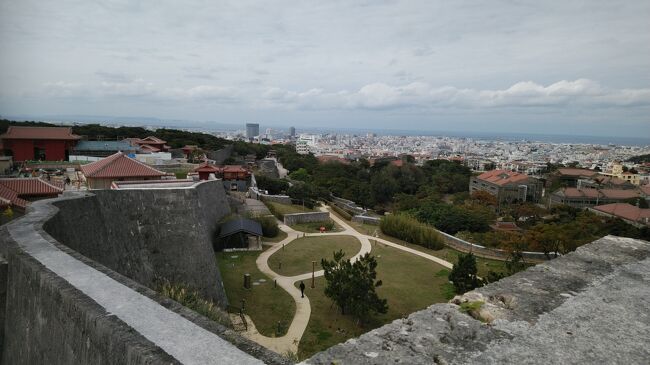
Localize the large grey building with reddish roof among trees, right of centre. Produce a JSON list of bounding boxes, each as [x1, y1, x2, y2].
[[469, 170, 542, 203]]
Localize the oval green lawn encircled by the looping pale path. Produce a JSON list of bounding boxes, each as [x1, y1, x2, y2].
[[268, 235, 361, 276]]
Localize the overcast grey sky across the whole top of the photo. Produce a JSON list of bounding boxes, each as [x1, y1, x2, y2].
[[0, 0, 650, 136]]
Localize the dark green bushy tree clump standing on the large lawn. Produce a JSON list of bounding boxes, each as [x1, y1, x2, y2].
[[321, 250, 388, 322]]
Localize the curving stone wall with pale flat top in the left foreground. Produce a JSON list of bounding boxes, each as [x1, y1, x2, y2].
[[0, 191, 290, 365]]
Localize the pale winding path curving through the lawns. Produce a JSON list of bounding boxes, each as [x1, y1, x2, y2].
[[235, 207, 453, 354]]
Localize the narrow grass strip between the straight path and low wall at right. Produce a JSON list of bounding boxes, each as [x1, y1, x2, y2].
[[349, 216, 506, 277]]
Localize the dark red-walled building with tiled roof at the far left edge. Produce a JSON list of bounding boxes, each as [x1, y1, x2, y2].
[[0, 126, 81, 161]]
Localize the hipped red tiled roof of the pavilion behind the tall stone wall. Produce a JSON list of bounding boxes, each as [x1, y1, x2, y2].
[[81, 152, 165, 178]]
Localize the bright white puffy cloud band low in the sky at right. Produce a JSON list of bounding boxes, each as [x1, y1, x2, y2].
[[262, 79, 650, 109]]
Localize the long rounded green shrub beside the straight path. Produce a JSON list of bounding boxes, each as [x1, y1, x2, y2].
[[379, 214, 444, 250]]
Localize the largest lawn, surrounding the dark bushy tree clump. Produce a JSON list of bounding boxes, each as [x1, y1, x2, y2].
[[298, 240, 453, 359]]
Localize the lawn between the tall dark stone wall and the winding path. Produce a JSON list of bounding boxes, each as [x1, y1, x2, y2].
[[217, 251, 296, 337]]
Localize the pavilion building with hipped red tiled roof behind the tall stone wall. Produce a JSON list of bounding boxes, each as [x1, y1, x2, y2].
[[81, 152, 166, 189]]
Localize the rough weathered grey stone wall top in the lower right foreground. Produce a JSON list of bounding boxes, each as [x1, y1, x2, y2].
[[304, 236, 650, 365]]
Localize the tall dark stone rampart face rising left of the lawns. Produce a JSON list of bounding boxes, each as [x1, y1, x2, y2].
[[44, 181, 230, 306]]
